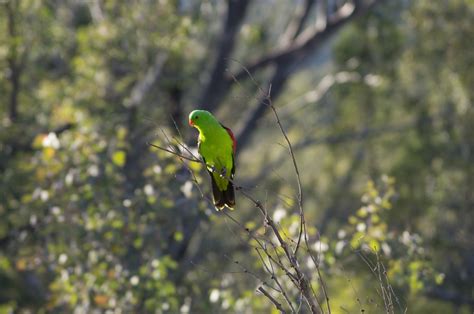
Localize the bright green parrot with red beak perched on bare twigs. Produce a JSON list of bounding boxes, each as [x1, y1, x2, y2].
[[189, 110, 236, 210]]
